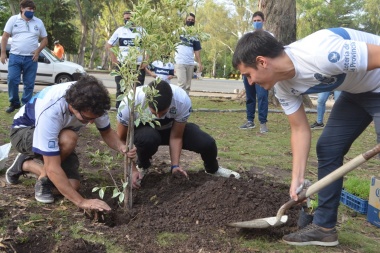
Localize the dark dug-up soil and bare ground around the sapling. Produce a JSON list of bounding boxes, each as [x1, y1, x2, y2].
[[0, 125, 298, 253]]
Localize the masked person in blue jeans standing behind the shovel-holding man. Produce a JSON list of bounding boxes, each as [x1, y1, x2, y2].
[[240, 11, 273, 133]]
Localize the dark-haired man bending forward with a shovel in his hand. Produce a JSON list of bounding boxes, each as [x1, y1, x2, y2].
[[233, 28, 380, 246]]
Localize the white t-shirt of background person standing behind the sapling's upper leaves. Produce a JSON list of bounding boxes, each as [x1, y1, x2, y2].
[[108, 26, 145, 65]]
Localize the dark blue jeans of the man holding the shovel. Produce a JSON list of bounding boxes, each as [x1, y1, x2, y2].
[[313, 92, 380, 228]]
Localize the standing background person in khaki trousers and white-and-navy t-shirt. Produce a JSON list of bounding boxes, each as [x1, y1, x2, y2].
[[174, 13, 203, 94]]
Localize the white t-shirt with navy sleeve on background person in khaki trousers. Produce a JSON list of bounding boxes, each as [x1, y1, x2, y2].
[[174, 35, 202, 65]]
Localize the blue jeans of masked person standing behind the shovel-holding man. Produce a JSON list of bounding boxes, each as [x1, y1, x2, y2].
[[243, 76, 268, 124]]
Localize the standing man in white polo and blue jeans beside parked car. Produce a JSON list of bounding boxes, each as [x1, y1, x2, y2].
[[1, 0, 48, 113]]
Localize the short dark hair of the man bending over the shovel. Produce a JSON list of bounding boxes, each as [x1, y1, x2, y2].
[[232, 30, 284, 69]]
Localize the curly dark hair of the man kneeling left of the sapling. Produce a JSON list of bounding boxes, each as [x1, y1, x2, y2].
[[65, 75, 111, 116]]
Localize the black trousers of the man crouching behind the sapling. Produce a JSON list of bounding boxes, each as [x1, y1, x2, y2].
[[134, 123, 219, 173]]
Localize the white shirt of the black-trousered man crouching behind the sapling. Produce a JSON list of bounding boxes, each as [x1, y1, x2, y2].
[[117, 84, 191, 130]]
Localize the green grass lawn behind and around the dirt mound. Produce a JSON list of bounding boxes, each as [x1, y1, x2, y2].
[[0, 93, 380, 252]]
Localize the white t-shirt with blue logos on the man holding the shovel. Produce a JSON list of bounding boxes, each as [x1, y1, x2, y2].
[[274, 28, 380, 115]]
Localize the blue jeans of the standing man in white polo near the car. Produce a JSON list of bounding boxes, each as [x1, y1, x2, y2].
[[8, 54, 38, 105]]
